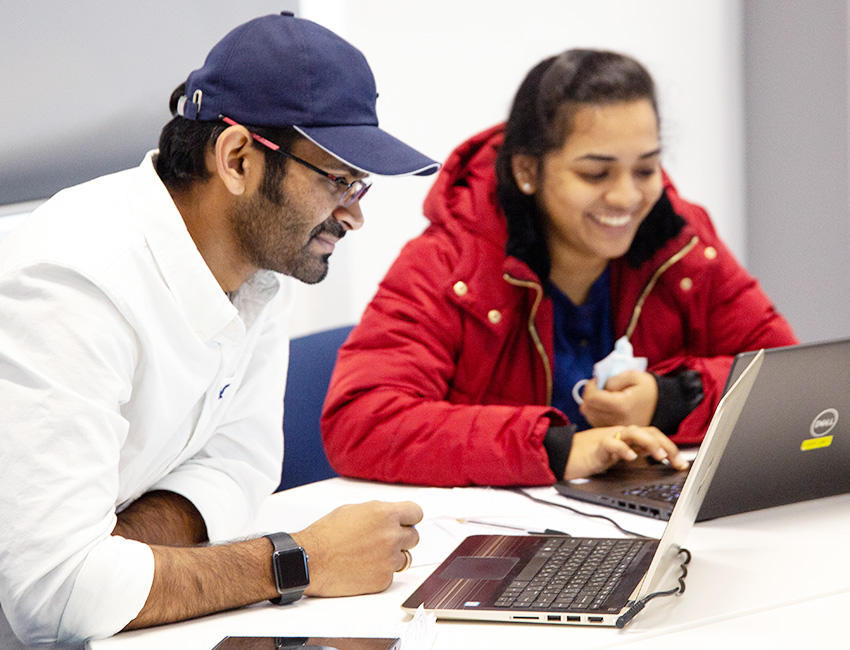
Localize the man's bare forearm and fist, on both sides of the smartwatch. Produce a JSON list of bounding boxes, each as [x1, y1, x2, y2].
[[116, 501, 422, 629]]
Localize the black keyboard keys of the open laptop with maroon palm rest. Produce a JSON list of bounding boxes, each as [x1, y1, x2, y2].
[[496, 537, 646, 610]]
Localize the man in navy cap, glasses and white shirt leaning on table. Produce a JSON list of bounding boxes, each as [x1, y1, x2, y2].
[[0, 14, 438, 643]]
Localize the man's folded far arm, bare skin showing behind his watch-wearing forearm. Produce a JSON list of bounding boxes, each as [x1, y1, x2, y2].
[[112, 490, 207, 546]]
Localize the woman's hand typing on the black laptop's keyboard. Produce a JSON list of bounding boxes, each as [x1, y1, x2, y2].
[[564, 426, 688, 481]]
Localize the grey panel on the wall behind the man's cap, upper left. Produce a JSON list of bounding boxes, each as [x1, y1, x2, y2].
[[0, 0, 298, 205]]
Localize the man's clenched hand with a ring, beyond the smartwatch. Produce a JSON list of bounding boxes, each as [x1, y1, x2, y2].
[[292, 501, 422, 596]]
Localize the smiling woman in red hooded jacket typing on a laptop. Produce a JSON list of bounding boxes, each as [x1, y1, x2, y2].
[[322, 50, 796, 485]]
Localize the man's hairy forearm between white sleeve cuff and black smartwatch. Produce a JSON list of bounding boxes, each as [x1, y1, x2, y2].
[[126, 537, 278, 629]]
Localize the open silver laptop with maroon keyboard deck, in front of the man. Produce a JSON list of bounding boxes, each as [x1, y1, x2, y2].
[[402, 352, 764, 627]]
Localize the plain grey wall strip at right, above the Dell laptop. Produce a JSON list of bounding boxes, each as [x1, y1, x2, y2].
[[743, 0, 850, 341]]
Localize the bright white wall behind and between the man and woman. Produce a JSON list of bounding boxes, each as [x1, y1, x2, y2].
[[286, 0, 746, 332]]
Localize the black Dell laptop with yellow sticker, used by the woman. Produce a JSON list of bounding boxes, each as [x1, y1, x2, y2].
[[556, 339, 850, 521]]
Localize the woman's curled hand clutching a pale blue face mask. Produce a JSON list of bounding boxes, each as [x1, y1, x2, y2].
[[579, 370, 658, 427]]
